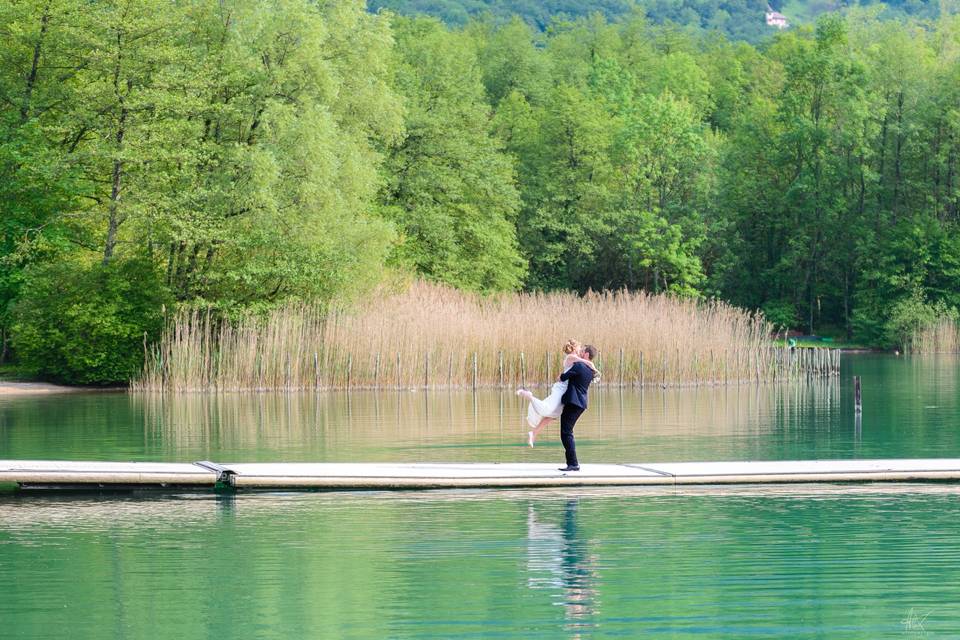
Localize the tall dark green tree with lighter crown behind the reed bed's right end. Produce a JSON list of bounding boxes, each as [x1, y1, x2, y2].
[[725, 17, 871, 332]]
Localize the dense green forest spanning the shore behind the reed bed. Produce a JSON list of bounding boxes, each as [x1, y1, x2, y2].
[[0, 0, 960, 382]]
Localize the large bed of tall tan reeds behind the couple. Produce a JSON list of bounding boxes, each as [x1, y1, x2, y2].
[[133, 282, 836, 391]]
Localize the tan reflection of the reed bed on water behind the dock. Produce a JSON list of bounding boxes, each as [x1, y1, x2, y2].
[[135, 383, 839, 463]]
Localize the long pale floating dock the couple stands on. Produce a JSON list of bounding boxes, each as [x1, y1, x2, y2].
[[0, 458, 960, 491]]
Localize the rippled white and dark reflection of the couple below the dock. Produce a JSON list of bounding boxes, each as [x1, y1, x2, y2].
[[527, 500, 597, 637]]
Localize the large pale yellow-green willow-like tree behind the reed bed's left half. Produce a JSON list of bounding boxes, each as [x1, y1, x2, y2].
[[155, 0, 402, 306]]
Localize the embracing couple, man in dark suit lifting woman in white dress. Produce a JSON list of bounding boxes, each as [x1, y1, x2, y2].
[[517, 340, 600, 471]]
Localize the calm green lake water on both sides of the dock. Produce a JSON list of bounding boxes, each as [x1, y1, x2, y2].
[[0, 356, 960, 640]]
